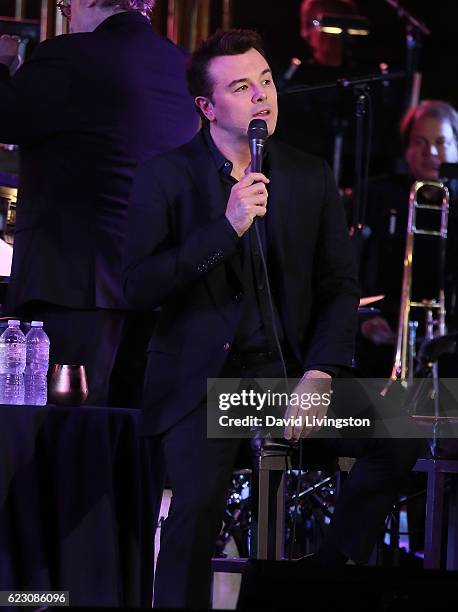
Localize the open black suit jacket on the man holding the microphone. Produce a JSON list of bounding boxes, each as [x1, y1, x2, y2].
[[125, 133, 359, 434]]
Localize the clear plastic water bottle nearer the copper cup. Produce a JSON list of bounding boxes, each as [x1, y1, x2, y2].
[[24, 321, 49, 406]]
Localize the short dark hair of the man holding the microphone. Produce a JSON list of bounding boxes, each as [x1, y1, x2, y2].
[[186, 29, 264, 109]]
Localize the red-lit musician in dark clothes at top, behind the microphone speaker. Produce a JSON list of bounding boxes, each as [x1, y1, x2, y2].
[[271, 0, 402, 187]]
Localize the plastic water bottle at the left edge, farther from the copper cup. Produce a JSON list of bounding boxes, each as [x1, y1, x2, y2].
[[0, 319, 26, 404]]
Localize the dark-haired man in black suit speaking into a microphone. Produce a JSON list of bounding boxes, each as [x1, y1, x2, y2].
[[125, 30, 415, 608]]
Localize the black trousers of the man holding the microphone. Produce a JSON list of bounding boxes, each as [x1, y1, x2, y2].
[[153, 356, 418, 609]]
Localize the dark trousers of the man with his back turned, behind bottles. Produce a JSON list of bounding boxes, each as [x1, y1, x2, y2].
[[20, 302, 125, 406]]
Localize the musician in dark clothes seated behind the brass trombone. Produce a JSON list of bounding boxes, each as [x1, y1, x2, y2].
[[357, 100, 458, 377]]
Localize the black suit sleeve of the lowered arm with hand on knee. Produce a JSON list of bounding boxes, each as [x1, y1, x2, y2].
[[304, 164, 360, 369]]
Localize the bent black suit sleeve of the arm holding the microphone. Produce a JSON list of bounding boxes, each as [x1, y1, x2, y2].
[[124, 160, 238, 309]]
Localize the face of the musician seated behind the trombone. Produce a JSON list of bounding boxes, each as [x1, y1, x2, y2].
[[406, 117, 458, 181]]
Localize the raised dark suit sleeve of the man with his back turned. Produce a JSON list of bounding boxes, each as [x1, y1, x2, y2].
[[0, 37, 71, 144]]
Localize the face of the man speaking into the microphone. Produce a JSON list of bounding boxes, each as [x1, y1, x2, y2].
[[198, 49, 278, 139]]
